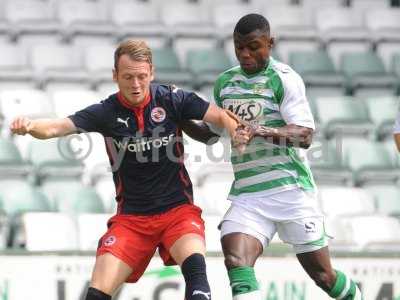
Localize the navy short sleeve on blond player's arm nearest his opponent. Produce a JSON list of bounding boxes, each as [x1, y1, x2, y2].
[[171, 88, 210, 121]]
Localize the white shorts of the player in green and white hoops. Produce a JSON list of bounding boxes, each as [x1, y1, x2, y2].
[[220, 189, 328, 254]]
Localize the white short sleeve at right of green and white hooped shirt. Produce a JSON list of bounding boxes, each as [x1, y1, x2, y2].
[[280, 70, 315, 129]]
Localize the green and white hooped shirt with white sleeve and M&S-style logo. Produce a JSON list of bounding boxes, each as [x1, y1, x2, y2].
[[212, 58, 315, 200]]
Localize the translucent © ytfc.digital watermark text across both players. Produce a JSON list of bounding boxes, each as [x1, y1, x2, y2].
[[57, 126, 343, 172]]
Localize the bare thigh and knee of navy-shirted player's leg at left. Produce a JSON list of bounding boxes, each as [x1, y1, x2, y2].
[[90, 253, 133, 295]]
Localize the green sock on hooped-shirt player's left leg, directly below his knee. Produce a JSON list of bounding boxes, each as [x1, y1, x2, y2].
[[228, 267, 258, 297]]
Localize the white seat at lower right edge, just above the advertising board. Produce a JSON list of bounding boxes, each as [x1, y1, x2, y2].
[[336, 215, 400, 253]]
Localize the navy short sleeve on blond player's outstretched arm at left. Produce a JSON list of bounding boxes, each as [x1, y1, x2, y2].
[[68, 103, 106, 134]]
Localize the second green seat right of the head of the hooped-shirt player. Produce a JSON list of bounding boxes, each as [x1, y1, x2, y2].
[[340, 52, 396, 95]]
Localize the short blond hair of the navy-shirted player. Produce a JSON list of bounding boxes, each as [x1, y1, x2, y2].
[[114, 39, 153, 71]]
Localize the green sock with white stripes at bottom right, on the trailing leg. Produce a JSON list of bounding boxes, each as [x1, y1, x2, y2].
[[328, 270, 362, 300]]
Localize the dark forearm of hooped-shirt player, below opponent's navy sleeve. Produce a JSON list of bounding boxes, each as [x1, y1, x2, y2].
[[179, 120, 219, 145]]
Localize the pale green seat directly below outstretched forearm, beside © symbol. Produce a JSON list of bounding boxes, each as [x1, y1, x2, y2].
[[27, 136, 83, 182]]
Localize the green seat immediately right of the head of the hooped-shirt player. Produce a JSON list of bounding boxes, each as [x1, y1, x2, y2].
[[289, 50, 345, 89]]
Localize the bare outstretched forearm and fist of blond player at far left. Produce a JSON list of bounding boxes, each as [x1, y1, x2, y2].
[[10, 117, 77, 139]]
